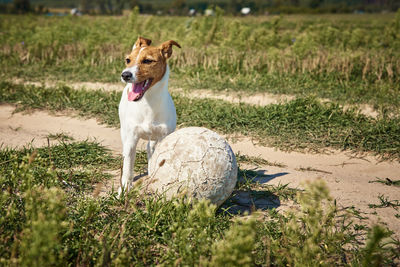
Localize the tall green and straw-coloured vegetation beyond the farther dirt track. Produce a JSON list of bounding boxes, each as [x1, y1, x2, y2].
[[0, 11, 400, 114]]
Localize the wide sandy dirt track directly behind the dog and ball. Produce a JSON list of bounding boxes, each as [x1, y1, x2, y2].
[[0, 105, 400, 238]]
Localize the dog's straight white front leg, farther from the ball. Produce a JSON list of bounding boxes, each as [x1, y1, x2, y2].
[[118, 137, 139, 195]]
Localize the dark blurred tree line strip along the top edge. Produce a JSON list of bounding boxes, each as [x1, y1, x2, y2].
[[0, 0, 400, 15]]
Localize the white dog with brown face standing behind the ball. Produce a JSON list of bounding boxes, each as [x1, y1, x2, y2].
[[118, 37, 181, 195]]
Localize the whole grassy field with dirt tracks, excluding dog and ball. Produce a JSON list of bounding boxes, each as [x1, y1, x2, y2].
[[0, 10, 400, 266]]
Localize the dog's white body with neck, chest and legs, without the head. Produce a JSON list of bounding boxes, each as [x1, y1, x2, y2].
[[119, 66, 176, 195]]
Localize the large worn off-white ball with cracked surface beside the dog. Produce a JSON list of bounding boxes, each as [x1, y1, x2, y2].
[[145, 127, 237, 206]]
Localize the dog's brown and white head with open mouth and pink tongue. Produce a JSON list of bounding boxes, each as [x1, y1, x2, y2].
[[121, 37, 181, 101]]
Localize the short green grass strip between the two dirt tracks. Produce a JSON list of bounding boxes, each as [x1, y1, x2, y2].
[[0, 82, 400, 159]]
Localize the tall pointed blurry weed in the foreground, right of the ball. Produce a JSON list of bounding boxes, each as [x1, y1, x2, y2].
[[269, 180, 346, 266]]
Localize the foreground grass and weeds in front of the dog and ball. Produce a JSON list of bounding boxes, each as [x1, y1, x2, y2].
[[0, 141, 399, 266]]
